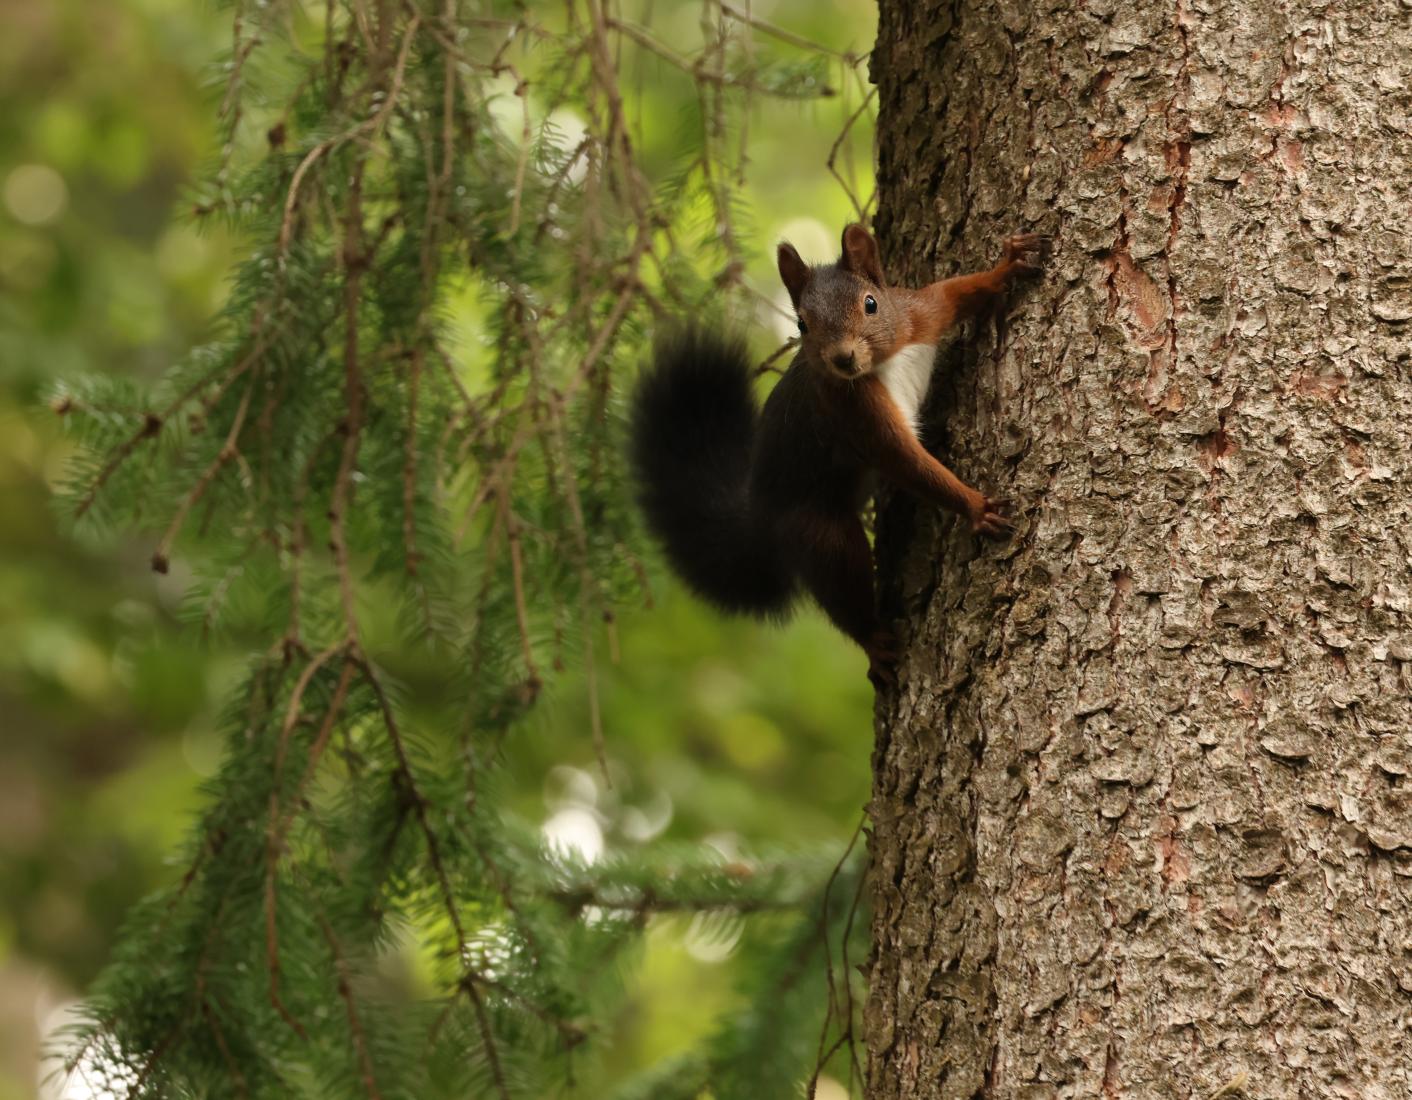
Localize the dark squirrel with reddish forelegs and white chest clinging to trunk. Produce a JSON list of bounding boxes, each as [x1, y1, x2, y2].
[[631, 225, 1048, 685]]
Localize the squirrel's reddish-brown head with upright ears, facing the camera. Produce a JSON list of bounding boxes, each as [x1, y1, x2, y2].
[[778, 223, 898, 378]]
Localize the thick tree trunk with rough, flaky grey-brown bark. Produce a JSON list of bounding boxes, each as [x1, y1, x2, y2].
[[866, 0, 1412, 1100]]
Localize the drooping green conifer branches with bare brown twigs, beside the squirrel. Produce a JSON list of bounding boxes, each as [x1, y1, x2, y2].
[[56, 0, 861, 1100]]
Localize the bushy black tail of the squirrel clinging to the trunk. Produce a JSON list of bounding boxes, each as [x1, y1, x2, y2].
[[631, 326, 794, 617]]
